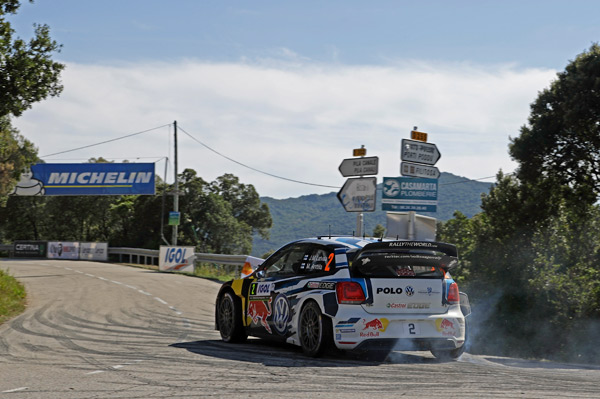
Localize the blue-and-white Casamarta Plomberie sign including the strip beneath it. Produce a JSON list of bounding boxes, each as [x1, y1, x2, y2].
[[381, 177, 438, 212]]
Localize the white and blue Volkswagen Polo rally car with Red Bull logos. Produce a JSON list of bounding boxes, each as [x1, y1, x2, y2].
[[215, 237, 470, 359]]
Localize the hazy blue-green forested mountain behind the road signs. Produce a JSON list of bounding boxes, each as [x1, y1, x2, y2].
[[252, 172, 492, 256]]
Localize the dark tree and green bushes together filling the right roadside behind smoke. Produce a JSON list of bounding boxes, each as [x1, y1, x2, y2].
[[439, 45, 600, 362]]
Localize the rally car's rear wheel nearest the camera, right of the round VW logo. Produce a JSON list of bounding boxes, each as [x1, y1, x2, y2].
[[298, 301, 333, 357]]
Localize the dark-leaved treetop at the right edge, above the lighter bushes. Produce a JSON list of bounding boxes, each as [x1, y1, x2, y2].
[[510, 44, 600, 204]]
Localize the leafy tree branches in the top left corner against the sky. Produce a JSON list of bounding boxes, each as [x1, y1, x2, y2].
[[0, 0, 64, 117]]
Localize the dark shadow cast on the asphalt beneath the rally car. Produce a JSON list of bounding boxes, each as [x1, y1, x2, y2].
[[170, 339, 438, 367]]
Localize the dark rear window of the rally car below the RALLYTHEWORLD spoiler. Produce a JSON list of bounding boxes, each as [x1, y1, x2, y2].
[[350, 251, 455, 279]]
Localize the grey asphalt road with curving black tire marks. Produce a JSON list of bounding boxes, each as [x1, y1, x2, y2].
[[0, 260, 600, 399]]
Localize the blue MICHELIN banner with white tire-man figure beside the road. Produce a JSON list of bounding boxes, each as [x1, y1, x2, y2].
[[11, 163, 155, 195]]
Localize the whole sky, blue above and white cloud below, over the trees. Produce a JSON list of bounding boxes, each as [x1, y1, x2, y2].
[[7, 0, 600, 198]]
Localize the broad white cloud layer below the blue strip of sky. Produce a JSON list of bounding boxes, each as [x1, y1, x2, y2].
[[14, 57, 556, 198]]
